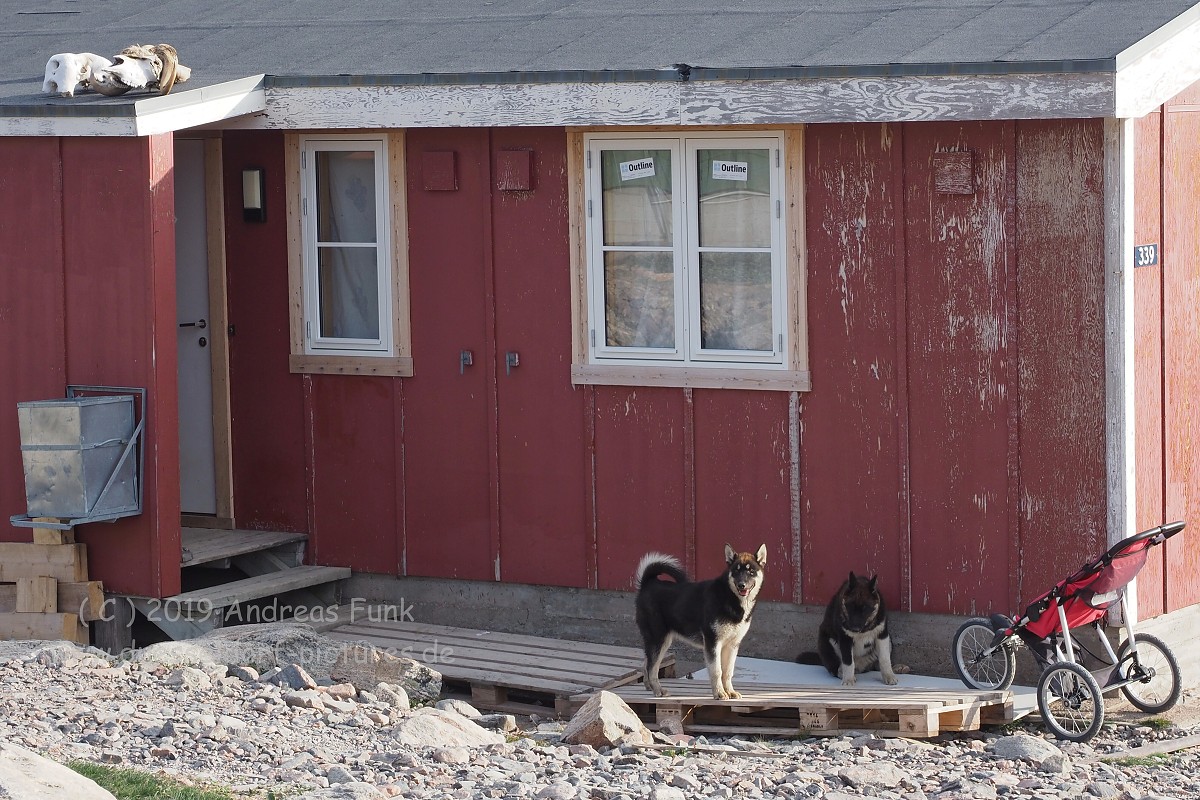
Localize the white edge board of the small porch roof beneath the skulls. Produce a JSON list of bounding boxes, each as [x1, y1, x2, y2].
[[0, 76, 266, 136]]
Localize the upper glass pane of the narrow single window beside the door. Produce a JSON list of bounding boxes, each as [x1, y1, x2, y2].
[[313, 150, 376, 242]]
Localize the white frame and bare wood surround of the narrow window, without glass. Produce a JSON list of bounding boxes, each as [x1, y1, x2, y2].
[[286, 131, 413, 377]]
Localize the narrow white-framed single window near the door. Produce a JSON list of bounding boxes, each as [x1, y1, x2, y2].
[[300, 137, 396, 357]]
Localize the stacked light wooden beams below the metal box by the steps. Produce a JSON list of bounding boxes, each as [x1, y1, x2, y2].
[[0, 518, 104, 644]]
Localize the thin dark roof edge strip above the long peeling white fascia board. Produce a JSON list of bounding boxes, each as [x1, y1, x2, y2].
[[265, 59, 1116, 89]]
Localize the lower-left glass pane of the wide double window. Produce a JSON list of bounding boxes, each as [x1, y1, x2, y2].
[[604, 252, 674, 348]]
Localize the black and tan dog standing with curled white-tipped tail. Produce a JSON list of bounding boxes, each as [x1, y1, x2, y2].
[[634, 545, 767, 700]]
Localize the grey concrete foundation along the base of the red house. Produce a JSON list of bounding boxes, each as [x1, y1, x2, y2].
[[342, 573, 1200, 688]]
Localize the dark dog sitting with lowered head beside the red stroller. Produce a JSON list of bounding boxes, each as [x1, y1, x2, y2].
[[796, 572, 896, 686]]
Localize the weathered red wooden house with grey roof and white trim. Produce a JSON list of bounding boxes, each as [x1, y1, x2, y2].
[[0, 0, 1200, 671]]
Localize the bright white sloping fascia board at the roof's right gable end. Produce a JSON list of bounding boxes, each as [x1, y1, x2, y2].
[[1114, 14, 1200, 119]]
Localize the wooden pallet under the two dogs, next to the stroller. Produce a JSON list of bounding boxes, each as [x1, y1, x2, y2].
[[597, 679, 1013, 738]]
